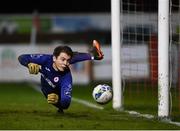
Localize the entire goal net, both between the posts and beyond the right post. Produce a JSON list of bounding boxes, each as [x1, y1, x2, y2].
[[120, 0, 180, 121]]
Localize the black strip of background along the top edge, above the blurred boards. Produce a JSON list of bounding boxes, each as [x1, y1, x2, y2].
[[0, 0, 179, 14]]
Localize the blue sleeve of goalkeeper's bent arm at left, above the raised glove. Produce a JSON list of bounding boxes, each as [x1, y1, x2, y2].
[[18, 54, 48, 66]]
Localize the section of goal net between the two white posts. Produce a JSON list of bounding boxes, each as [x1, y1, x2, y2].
[[120, 0, 158, 115]]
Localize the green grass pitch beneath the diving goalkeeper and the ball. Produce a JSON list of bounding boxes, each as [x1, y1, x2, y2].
[[0, 83, 180, 130]]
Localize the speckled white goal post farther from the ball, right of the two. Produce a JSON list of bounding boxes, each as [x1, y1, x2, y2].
[[158, 0, 169, 118]]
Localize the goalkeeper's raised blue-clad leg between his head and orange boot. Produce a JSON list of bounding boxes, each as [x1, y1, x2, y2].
[[70, 52, 92, 64]]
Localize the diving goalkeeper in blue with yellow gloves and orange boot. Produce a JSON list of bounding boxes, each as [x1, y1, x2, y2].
[[18, 40, 103, 113]]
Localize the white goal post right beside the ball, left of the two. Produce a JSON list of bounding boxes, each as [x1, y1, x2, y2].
[[111, 0, 123, 110]]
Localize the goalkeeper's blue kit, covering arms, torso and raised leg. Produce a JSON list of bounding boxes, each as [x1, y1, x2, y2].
[[18, 53, 91, 109]]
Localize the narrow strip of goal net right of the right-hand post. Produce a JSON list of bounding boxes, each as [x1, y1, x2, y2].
[[169, 0, 180, 121]]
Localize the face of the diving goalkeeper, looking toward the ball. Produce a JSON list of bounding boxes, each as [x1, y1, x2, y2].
[[53, 52, 71, 71]]
